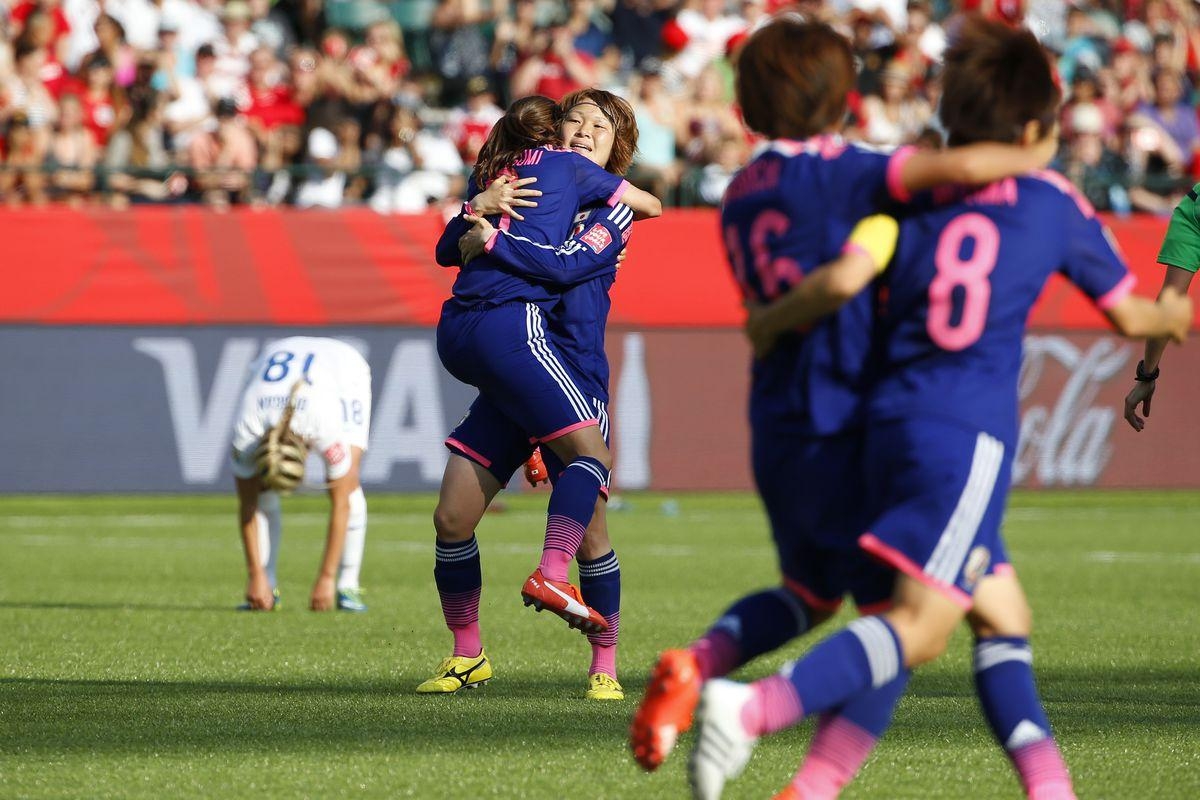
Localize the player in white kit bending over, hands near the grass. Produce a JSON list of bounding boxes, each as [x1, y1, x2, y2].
[[233, 336, 371, 612]]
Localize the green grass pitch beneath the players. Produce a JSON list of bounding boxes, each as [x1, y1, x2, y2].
[[0, 492, 1200, 800]]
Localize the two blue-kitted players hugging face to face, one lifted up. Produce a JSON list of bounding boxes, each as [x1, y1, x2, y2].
[[418, 90, 661, 699]]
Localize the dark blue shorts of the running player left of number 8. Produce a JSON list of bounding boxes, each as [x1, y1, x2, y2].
[[752, 429, 895, 613]]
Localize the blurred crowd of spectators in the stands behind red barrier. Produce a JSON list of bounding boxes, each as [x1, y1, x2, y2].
[[0, 0, 1200, 213]]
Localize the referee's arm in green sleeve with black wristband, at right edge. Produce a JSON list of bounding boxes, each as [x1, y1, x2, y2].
[[1126, 184, 1200, 431]]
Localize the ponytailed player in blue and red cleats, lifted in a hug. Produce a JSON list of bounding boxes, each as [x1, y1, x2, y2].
[[438, 97, 661, 633]]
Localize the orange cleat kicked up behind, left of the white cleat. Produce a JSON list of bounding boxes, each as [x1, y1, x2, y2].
[[629, 650, 702, 772]]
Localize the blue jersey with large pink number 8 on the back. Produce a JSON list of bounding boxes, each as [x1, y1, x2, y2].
[[869, 170, 1134, 449]]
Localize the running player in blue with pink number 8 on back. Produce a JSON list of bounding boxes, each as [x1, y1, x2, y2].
[[689, 20, 1192, 800]]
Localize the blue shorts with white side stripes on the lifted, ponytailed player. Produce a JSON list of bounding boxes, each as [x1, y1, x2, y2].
[[438, 301, 599, 441]]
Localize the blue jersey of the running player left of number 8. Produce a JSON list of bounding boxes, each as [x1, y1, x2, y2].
[[721, 136, 911, 435]]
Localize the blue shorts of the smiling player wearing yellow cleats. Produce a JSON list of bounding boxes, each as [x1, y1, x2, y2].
[[445, 395, 608, 486]]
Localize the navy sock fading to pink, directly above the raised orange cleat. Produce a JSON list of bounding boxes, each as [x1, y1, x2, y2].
[[690, 588, 809, 680]]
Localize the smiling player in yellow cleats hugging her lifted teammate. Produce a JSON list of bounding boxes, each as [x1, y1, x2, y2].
[[418, 90, 652, 699]]
